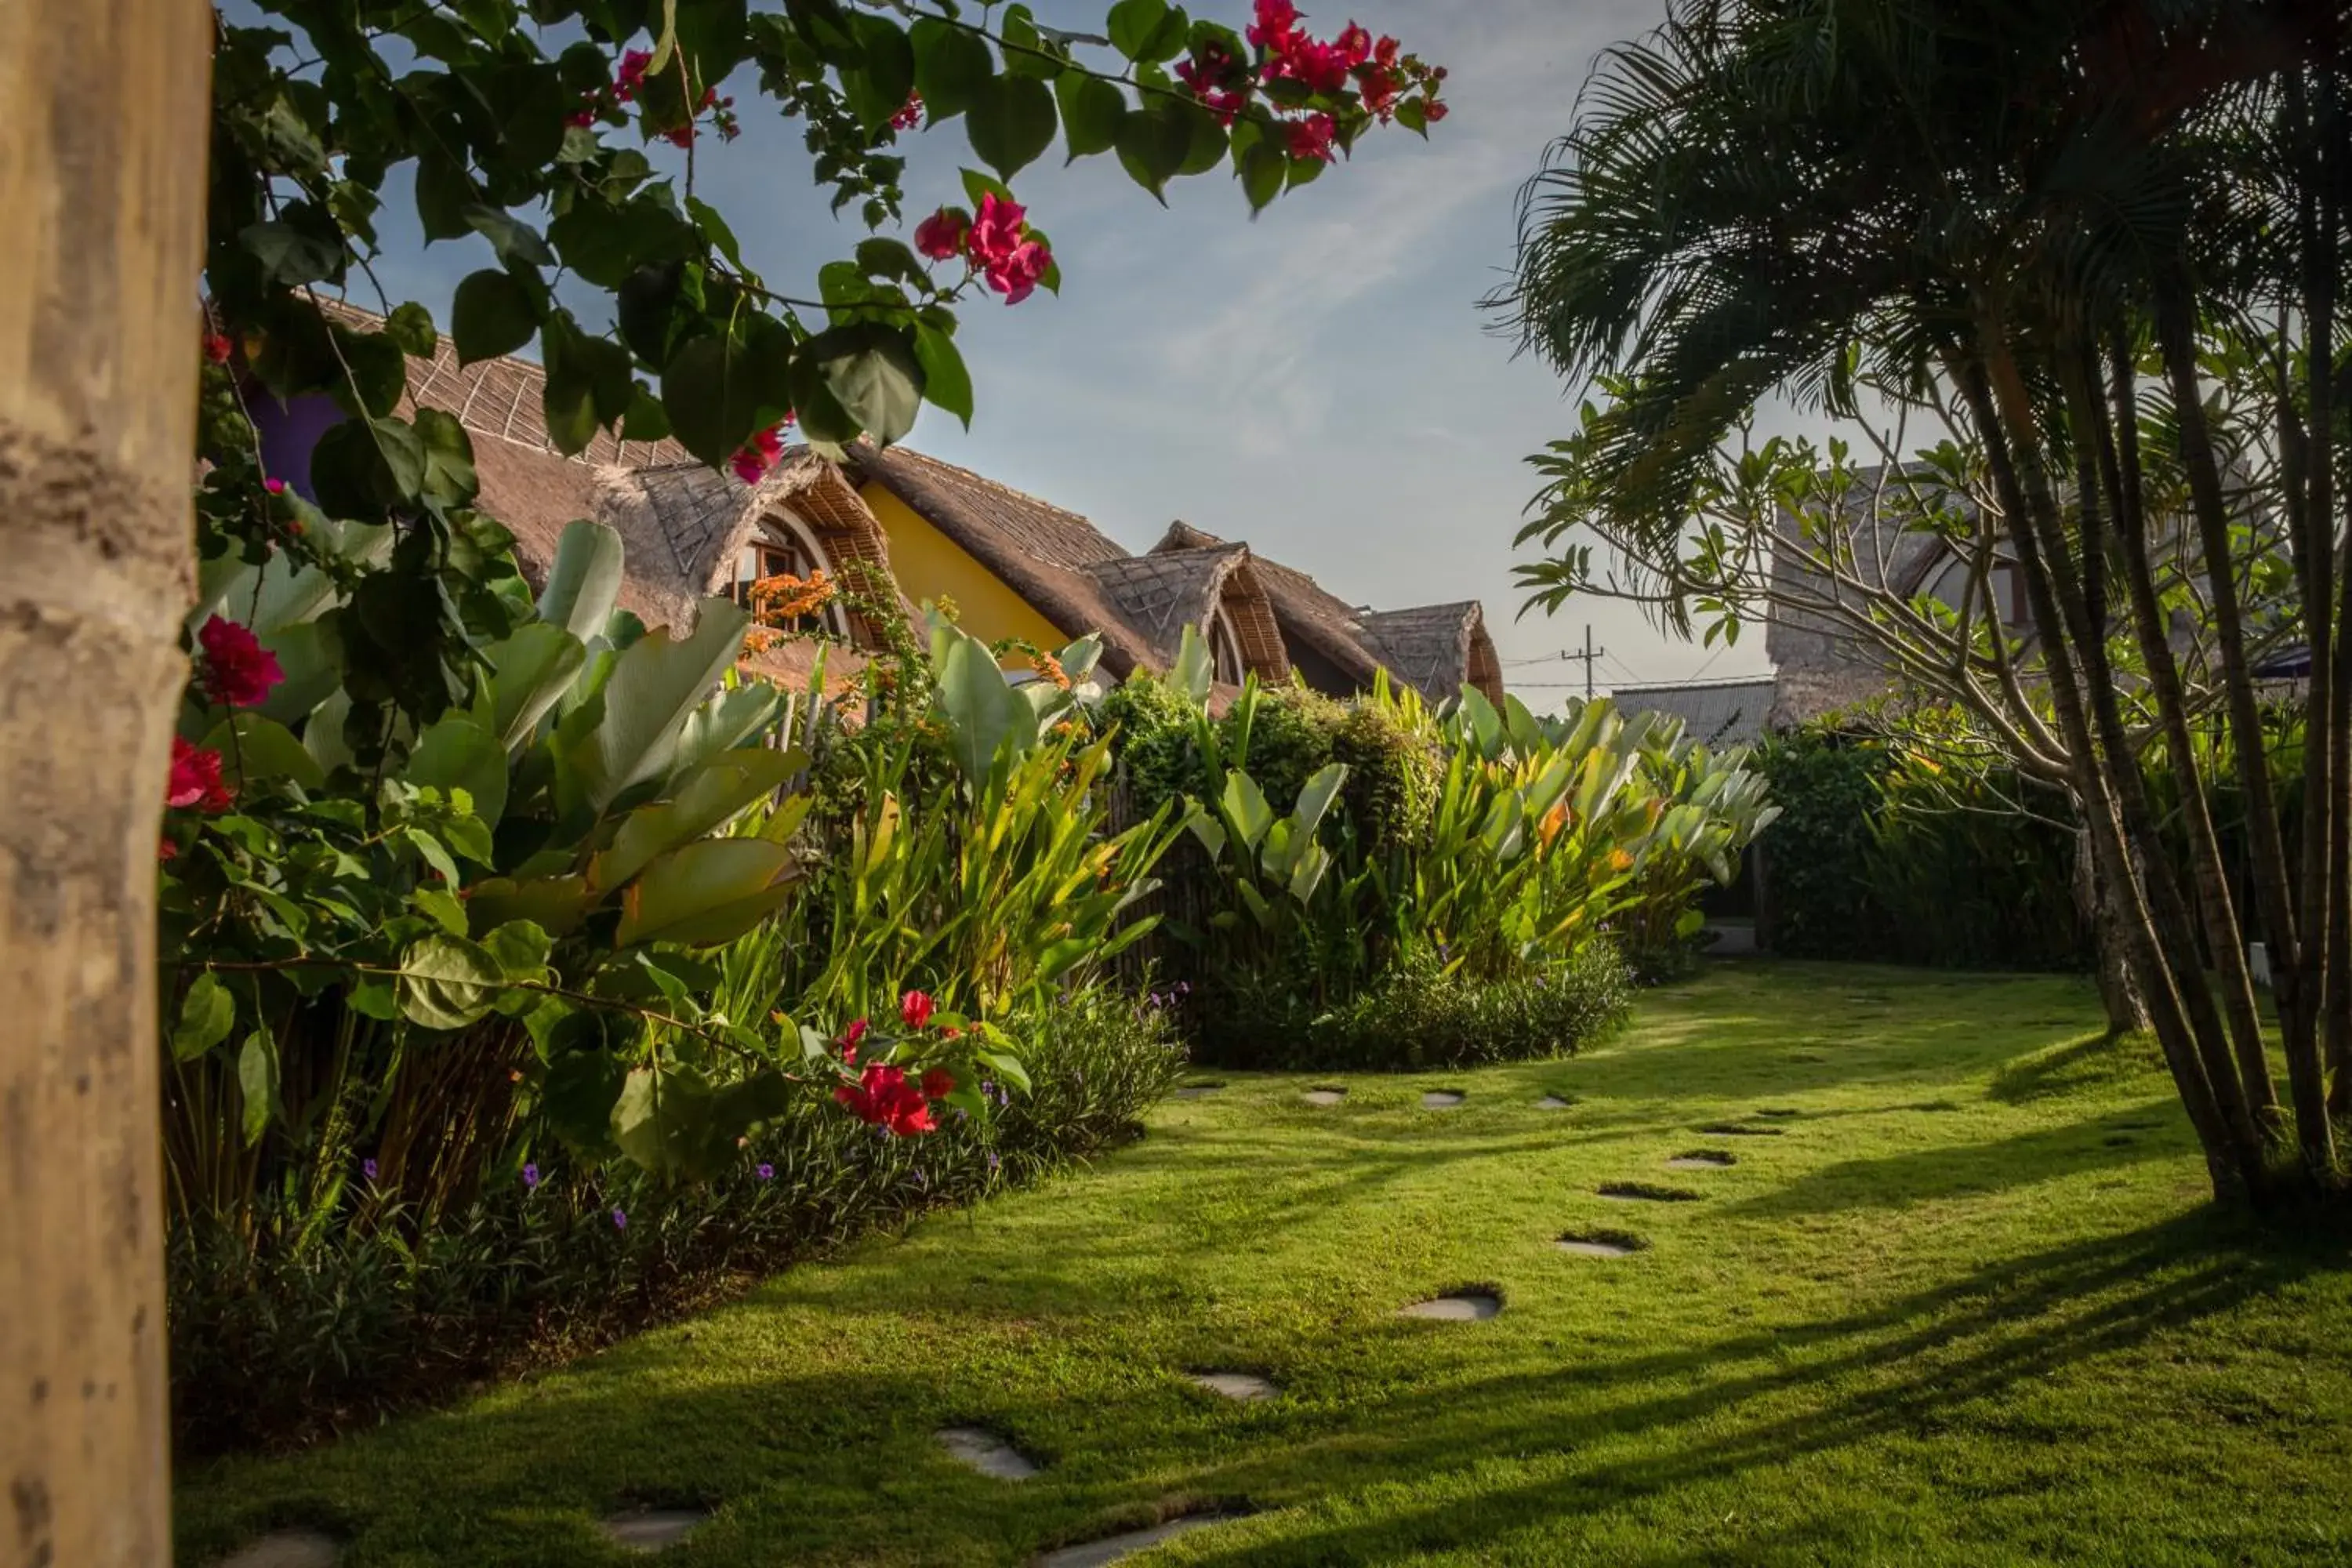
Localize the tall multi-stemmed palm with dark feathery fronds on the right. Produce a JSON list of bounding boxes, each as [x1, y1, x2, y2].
[[1496, 0, 2352, 1196]]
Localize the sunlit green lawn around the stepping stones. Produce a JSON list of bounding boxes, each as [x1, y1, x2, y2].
[[179, 964, 2352, 1568]]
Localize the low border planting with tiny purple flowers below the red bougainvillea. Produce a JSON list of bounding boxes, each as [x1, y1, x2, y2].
[[169, 987, 1183, 1453]]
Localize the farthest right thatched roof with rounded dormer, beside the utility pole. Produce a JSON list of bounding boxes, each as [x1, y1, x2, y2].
[[1152, 522, 1503, 701]]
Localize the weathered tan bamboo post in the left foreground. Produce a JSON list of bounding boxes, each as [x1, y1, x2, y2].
[[0, 0, 212, 1568]]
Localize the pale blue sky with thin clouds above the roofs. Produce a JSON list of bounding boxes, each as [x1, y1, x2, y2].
[[332, 0, 1764, 710]]
